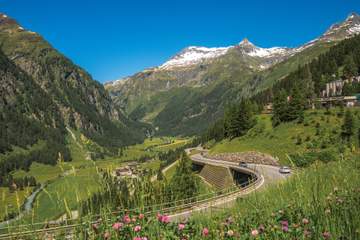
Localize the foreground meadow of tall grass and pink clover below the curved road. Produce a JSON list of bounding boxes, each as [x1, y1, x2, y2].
[[71, 156, 360, 240]]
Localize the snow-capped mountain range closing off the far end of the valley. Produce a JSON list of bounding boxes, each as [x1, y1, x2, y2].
[[105, 14, 360, 134]]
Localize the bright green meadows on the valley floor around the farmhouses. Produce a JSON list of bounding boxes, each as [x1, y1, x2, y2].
[[7, 135, 189, 222]]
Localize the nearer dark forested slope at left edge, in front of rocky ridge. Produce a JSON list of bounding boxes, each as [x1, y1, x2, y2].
[[0, 51, 71, 185]]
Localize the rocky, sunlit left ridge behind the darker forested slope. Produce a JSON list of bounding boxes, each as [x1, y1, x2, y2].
[[0, 14, 146, 148]]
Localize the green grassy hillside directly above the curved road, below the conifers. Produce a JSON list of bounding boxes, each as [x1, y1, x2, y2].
[[210, 110, 356, 163]]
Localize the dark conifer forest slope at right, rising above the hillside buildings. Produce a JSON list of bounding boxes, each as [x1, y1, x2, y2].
[[253, 36, 360, 104]]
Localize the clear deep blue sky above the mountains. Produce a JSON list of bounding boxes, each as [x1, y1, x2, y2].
[[0, 0, 360, 82]]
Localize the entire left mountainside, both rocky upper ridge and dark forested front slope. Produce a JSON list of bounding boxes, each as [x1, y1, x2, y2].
[[0, 14, 147, 185]]
